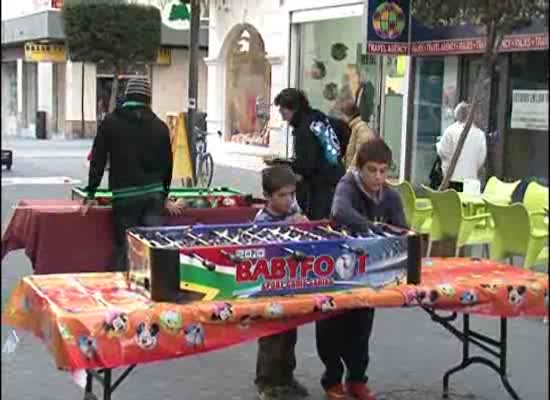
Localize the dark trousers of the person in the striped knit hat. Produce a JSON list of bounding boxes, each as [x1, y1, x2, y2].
[[111, 193, 166, 271]]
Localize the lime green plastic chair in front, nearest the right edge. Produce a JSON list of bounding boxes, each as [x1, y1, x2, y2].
[[486, 201, 548, 268]]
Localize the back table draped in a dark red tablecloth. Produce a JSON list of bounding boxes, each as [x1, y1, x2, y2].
[[2, 200, 258, 274]]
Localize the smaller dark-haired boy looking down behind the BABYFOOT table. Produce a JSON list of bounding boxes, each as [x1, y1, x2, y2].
[[255, 165, 308, 400]]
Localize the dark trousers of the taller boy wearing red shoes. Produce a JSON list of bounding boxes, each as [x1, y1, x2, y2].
[[315, 308, 374, 389]]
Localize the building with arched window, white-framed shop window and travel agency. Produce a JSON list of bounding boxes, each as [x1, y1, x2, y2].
[[206, 0, 548, 184]]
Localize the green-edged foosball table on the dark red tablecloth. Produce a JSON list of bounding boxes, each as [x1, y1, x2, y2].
[[71, 187, 261, 208]]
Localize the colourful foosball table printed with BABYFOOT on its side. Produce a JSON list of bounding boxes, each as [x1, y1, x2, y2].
[[128, 221, 421, 303]]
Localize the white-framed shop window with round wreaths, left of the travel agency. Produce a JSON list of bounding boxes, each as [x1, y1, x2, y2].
[[291, 2, 409, 178]]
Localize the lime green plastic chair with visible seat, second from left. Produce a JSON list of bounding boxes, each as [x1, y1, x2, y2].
[[424, 186, 494, 257]]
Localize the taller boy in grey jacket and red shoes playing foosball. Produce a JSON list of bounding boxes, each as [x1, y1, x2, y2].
[[316, 139, 407, 400]]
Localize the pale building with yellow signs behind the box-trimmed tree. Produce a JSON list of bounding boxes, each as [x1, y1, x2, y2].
[[2, 0, 208, 138]]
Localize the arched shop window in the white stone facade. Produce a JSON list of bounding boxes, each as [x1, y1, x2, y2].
[[222, 24, 271, 146]]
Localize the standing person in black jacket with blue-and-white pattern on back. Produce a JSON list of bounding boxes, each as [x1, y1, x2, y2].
[[275, 88, 344, 220]]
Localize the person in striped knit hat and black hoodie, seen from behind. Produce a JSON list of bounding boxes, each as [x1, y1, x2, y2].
[[83, 79, 180, 271]]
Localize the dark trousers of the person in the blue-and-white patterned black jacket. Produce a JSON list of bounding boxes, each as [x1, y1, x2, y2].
[[296, 182, 336, 221]]
